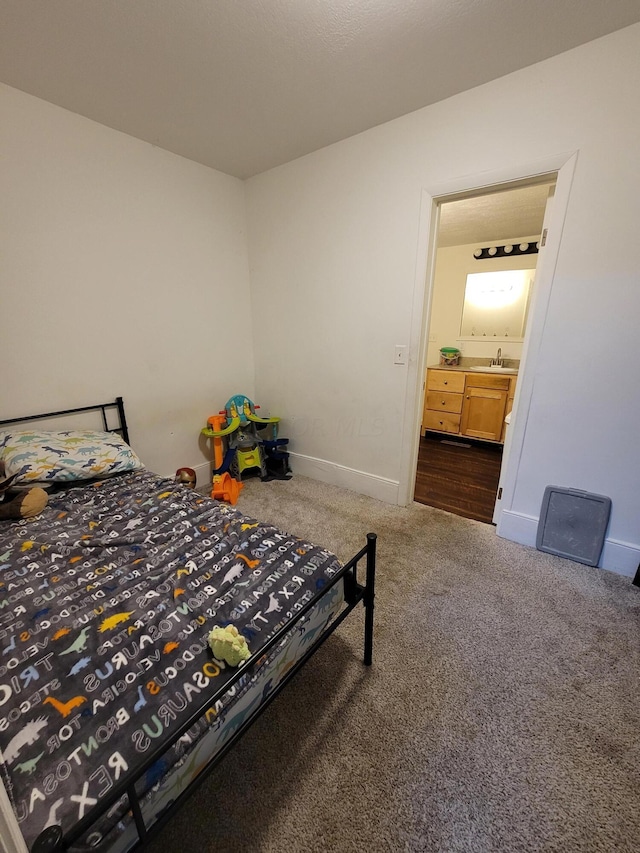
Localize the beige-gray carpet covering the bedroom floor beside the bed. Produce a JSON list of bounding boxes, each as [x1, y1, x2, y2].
[[150, 476, 640, 853]]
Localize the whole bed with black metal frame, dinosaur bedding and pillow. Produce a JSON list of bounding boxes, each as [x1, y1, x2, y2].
[[0, 398, 376, 853]]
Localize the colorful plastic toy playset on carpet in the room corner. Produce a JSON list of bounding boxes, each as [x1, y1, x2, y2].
[[201, 394, 290, 504]]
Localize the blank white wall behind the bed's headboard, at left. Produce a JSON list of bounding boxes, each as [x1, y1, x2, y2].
[[0, 85, 254, 482]]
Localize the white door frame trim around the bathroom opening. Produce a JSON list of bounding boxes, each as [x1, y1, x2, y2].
[[398, 151, 578, 510]]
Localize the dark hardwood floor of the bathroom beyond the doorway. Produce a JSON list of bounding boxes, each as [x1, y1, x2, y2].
[[414, 433, 502, 522]]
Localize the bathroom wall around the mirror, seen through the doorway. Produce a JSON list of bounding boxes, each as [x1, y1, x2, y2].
[[427, 234, 540, 365]]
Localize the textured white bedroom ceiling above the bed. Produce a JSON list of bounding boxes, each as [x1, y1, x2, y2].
[[0, 0, 640, 178]]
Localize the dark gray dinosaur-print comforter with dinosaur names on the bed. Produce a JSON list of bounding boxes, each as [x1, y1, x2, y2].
[[0, 470, 340, 849]]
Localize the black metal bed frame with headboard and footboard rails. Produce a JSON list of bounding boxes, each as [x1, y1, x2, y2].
[[0, 397, 376, 853]]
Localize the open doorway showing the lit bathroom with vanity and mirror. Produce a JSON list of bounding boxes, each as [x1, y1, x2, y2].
[[413, 181, 556, 523]]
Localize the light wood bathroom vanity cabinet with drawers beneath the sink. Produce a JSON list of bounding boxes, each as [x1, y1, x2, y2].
[[422, 367, 518, 442]]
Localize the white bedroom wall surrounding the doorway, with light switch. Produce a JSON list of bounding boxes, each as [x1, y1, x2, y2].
[[247, 25, 640, 573]]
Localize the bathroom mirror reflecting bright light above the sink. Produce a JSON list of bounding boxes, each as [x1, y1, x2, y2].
[[460, 269, 535, 341]]
